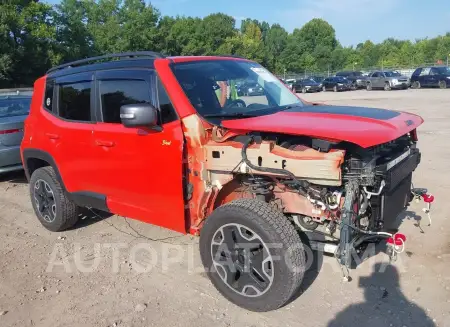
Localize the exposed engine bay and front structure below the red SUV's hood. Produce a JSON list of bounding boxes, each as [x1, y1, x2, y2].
[[203, 128, 428, 266]]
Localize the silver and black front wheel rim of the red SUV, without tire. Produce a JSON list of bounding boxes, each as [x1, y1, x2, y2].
[[211, 223, 274, 297]]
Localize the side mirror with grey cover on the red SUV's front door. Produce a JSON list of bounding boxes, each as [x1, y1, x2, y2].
[[120, 103, 159, 129]]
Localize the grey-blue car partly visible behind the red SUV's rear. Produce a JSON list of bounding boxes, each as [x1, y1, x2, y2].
[[0, 89, 33, 174]]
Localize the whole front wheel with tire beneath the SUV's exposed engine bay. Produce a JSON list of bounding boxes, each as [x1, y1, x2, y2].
[[200, 199, 306, 311]]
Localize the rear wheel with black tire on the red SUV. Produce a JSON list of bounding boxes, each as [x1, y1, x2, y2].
[[30, 167, 79, 232]]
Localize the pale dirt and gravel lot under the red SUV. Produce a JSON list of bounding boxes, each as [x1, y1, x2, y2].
[[0, 90, 450, 327]]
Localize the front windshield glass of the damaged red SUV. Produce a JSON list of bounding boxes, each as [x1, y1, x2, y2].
[[172, 60, 303, 117]]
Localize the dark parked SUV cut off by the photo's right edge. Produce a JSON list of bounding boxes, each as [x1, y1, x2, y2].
[[411, 66, 450, 89]]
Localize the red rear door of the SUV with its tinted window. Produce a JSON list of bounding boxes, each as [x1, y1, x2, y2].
[[49, 72, 98, 192]]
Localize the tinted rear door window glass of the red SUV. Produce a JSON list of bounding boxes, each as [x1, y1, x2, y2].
[[58, 82, 92, 121]]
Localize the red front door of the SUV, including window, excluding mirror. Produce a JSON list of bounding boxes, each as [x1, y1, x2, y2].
[[93, 69, 186, 232]]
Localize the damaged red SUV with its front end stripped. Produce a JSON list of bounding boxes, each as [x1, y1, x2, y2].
[[21, 52, 426, 311]]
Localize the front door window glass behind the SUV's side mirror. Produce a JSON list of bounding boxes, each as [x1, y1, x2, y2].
[[99, 80, 151, 124]]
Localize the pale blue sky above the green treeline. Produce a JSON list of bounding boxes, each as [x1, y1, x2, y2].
[[47, 0, 450, 46]]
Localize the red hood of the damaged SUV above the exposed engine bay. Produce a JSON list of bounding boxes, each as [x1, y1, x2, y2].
[[222, 111, 423, 148]]
